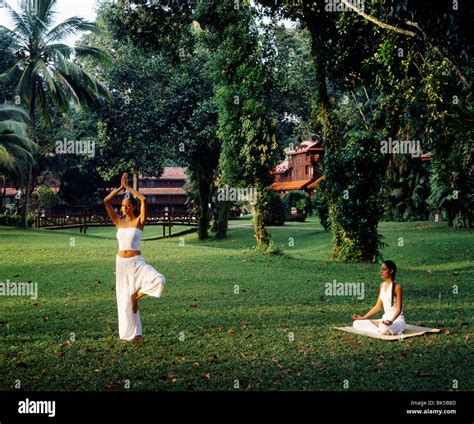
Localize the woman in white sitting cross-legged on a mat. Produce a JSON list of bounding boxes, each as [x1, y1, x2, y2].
[[352, 261, 406, 335]]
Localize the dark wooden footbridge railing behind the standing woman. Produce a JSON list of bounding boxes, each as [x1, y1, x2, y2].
[[35, 211, 198, 237]]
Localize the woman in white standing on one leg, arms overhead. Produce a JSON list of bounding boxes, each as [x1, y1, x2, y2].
[[104, 174, 166, 341]]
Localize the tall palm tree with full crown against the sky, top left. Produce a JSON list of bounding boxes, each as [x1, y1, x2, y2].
[[0, 0, 111, 226]]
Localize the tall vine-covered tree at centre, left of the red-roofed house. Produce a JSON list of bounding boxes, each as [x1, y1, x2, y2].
[[197, 0, 279, 251]]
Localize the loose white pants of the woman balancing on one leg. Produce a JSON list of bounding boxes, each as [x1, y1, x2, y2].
[[115, 255, 166, 340]]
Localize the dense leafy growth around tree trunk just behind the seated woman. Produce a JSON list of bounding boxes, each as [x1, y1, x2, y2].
[[324, 130, 385, 262]]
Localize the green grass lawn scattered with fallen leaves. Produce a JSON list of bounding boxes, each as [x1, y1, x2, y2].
[[0, 217, 474, 391]]
